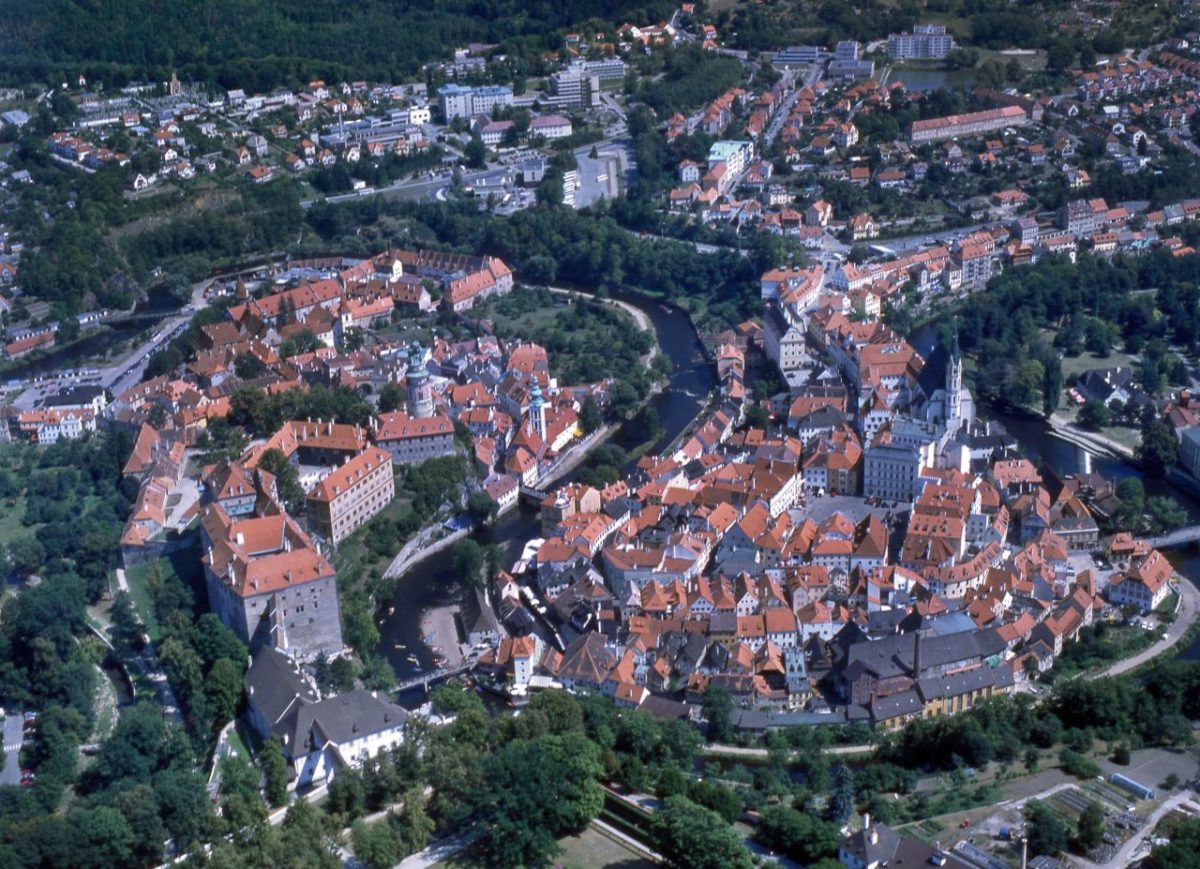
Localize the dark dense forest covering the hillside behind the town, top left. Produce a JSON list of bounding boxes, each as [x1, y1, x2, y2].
[[0, 0, 674, 92]]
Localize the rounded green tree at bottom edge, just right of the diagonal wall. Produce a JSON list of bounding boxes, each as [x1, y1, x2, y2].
[[650, 797, 754, 869]]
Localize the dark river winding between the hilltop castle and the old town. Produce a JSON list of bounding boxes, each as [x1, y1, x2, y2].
[[379, 293, 716, 681]]
